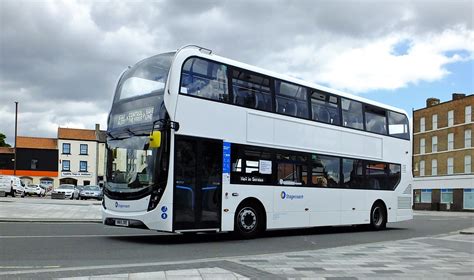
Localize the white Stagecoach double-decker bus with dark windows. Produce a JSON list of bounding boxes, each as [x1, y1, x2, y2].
[[102, 46, 413, 238]]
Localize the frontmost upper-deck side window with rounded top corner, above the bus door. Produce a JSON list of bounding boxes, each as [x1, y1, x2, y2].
[[181, 57, 229, 102]]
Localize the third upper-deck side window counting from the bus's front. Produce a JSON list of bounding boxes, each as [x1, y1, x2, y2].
[[275, 80, 308, 118]]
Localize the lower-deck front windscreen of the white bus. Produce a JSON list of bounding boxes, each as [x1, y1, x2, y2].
[[107, 136, 158, 192]]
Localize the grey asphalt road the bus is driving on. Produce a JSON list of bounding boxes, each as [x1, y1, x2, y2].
[[0, 216, 473, 272]]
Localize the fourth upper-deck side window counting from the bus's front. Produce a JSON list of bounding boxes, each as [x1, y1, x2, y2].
[[311, 91, 341, 125]]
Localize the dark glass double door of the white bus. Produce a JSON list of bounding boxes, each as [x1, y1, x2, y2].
[[173, 135, 222, 230]]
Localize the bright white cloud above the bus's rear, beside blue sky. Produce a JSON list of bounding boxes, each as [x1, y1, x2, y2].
[[263, 27, 474, 93]]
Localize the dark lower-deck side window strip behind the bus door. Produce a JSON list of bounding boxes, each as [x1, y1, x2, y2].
[[230, 144, 401, 190]]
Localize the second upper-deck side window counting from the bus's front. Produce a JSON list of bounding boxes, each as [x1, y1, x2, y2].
[[232, 69, 272, 112]]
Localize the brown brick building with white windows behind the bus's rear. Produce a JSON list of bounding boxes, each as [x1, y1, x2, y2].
[[413, 94, 474, 210]]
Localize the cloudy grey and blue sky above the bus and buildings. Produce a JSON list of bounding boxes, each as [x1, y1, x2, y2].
[[0, 0, 474, 143]]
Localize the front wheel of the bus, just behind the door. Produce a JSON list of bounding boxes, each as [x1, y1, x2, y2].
[[235, 204, 264, 239]]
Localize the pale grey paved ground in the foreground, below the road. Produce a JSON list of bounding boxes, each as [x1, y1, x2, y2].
[[0, 229, 474, 280]]
